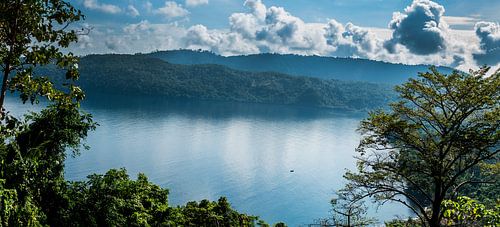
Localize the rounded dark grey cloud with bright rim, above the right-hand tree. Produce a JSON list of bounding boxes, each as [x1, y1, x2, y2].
[[385, 0, 448, 55]]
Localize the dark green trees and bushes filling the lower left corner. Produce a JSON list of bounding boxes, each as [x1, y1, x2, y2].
[[0, 105, 278, 227]]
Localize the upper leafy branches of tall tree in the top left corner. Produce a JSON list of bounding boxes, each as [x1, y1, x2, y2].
[[0, 0, 83, 117]]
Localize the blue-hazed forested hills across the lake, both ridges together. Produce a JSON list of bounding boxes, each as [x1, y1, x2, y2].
[[34, 50, 458, 110]]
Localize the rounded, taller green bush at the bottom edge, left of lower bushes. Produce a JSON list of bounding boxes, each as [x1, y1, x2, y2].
[[61, 169, 171, 226]]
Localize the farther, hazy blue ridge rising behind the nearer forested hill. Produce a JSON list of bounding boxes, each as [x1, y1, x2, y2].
[[147, 50, 452, 84]]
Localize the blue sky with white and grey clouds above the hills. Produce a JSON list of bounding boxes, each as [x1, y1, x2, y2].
[[71, 0, 500, 70]]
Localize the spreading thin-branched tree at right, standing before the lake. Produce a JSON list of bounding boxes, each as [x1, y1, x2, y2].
[[341, 68, 500, 227]]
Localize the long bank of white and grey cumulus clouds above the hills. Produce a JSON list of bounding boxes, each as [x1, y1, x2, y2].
[[71, 0, 500, 70]]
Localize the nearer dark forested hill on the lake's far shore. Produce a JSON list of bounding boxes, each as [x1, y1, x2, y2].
[[37, 55, 394, 110]]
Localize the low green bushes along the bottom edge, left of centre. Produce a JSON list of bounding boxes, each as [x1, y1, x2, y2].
[[60, 169, 264, 226]]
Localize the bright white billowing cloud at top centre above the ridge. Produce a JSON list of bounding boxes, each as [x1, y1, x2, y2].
[[229, 0, 334, 54]]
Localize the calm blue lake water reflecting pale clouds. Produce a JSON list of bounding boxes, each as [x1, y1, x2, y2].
[[6, 93, 408, 226]]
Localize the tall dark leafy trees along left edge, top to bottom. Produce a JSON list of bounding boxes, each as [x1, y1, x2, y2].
[[0, 0, 95, 226]]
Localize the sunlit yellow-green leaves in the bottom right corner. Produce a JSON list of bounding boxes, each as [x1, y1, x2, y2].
[[442, 196, 500, 226]]
